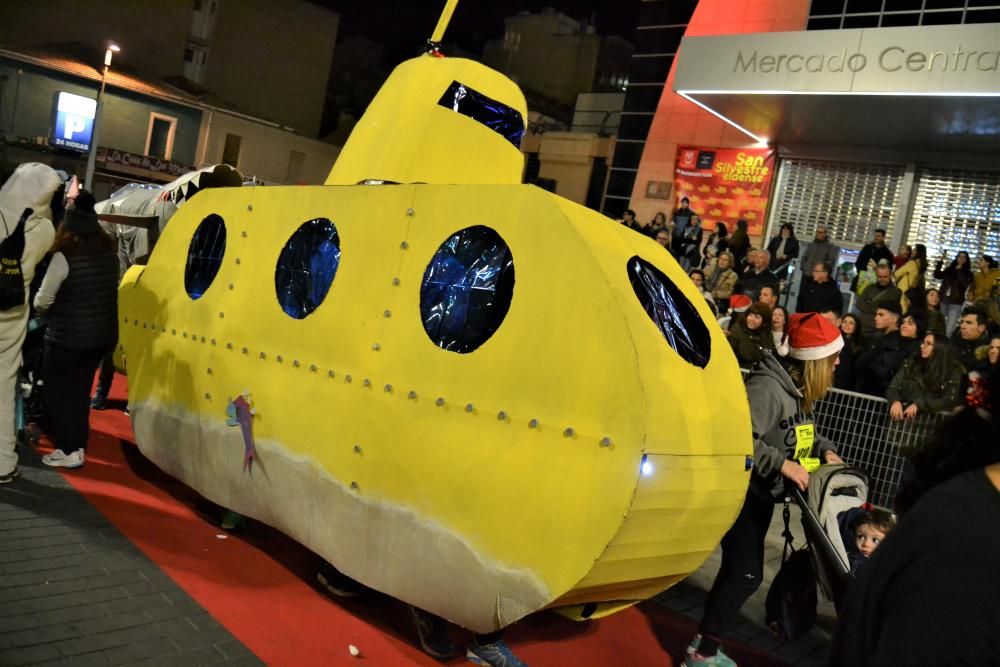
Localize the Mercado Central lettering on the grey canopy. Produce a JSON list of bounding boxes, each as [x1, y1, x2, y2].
[[733, 45, 1000, 74]]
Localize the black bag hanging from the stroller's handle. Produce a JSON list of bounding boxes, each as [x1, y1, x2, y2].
[[764, 498, 817, 639]]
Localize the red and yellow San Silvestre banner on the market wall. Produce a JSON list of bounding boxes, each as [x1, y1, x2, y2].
[[674, 146, 775, 236]]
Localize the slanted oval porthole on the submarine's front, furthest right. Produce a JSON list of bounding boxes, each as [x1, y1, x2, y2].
[[628, 257, 712, 368]]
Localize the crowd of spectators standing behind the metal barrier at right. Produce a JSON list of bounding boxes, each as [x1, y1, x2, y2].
[[623, 207, 1000, 419]]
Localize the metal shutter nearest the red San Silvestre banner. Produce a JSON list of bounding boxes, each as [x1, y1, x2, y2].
[[770, 159, 904, 247]]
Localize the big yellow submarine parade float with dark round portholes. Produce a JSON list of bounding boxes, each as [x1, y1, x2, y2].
[[120, 2, 752, 632]]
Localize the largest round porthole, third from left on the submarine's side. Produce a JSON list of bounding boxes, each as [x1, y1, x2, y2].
[[420, 225, 514, 354]]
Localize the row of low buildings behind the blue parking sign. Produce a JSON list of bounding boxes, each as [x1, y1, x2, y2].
[[0, 46, 340, 198]]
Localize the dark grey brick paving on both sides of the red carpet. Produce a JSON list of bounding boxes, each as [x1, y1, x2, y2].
[[0, 440, 835, 666]]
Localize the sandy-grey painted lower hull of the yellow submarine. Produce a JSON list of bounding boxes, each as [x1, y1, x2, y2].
[[130, 402, 554, 632]]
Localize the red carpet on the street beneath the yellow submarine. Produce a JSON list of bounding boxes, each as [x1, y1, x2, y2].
[[40, 376, 778, 667]]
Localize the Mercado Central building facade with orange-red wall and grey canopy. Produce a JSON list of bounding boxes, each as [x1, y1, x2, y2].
[[616, 0, 1000, 260]]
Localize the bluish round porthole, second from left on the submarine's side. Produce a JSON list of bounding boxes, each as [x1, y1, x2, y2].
[[274, 218, 340, 320]]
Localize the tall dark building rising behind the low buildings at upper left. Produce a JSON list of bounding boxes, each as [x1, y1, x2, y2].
[[0, 0, 338, 138]]
